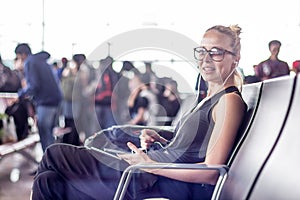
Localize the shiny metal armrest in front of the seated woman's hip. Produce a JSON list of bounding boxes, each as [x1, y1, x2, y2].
[[114, 163, 229, 200]]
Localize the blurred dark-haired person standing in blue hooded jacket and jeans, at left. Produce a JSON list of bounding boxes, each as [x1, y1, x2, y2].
[[15, 43, 62, 152]]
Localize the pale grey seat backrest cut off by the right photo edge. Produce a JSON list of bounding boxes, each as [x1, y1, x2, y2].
[[249, 76, 300, 199]]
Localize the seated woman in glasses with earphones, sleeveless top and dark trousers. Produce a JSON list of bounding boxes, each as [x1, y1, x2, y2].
[[32, 26, 246, 199]]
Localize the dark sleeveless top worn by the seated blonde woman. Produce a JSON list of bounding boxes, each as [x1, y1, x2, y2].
[[148, 86, 246, 163]]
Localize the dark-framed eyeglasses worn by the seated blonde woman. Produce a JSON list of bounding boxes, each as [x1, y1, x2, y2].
[[194, 47, 235, 62]]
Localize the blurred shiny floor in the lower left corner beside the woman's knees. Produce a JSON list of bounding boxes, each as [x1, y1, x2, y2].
[[0, 145, 41, 200]]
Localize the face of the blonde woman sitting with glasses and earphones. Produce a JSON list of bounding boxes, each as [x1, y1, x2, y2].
[[199, 30, 236, 84]]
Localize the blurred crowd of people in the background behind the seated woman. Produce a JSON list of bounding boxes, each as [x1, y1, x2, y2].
[[0, 40, 300, 150]]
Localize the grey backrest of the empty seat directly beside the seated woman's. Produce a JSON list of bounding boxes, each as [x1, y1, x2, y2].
[[219, 77, 294, 199]]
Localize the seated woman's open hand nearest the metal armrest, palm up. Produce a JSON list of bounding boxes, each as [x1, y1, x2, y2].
[[118, 142, 154, 165]]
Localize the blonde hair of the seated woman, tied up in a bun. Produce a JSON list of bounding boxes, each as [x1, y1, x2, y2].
[[206, 24, 244, 91]]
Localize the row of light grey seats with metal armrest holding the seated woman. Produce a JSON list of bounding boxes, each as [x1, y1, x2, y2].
[[114, 76, 300, 199]]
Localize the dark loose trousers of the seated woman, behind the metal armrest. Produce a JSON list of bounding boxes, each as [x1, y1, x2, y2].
[[32, 140, 214, 200]]
